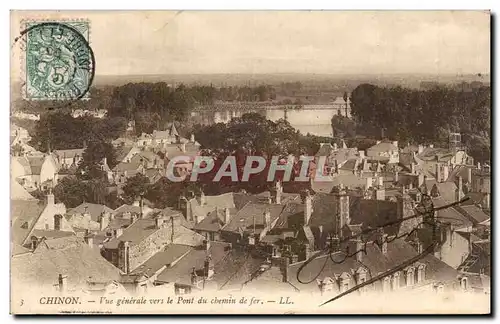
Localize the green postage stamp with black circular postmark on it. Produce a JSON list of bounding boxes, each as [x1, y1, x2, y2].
[[21, 21, 95, 100]]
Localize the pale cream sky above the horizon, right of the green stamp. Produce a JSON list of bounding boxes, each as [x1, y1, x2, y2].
[[11, 11, 490, 75]]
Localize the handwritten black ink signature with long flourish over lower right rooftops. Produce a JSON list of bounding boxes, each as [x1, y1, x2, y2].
[[297, 195, 469, 306]]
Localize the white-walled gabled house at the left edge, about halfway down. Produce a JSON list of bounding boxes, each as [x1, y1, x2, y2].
[[11, 154, 60, 191]]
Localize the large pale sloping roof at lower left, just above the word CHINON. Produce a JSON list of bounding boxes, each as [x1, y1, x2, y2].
[[11, 240, 120, 287]]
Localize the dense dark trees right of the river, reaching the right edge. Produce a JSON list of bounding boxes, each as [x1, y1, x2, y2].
[[346, 84, 491, 161]]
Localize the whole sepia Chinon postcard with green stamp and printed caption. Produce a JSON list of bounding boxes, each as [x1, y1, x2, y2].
[[10, 11, 492, 314]]
